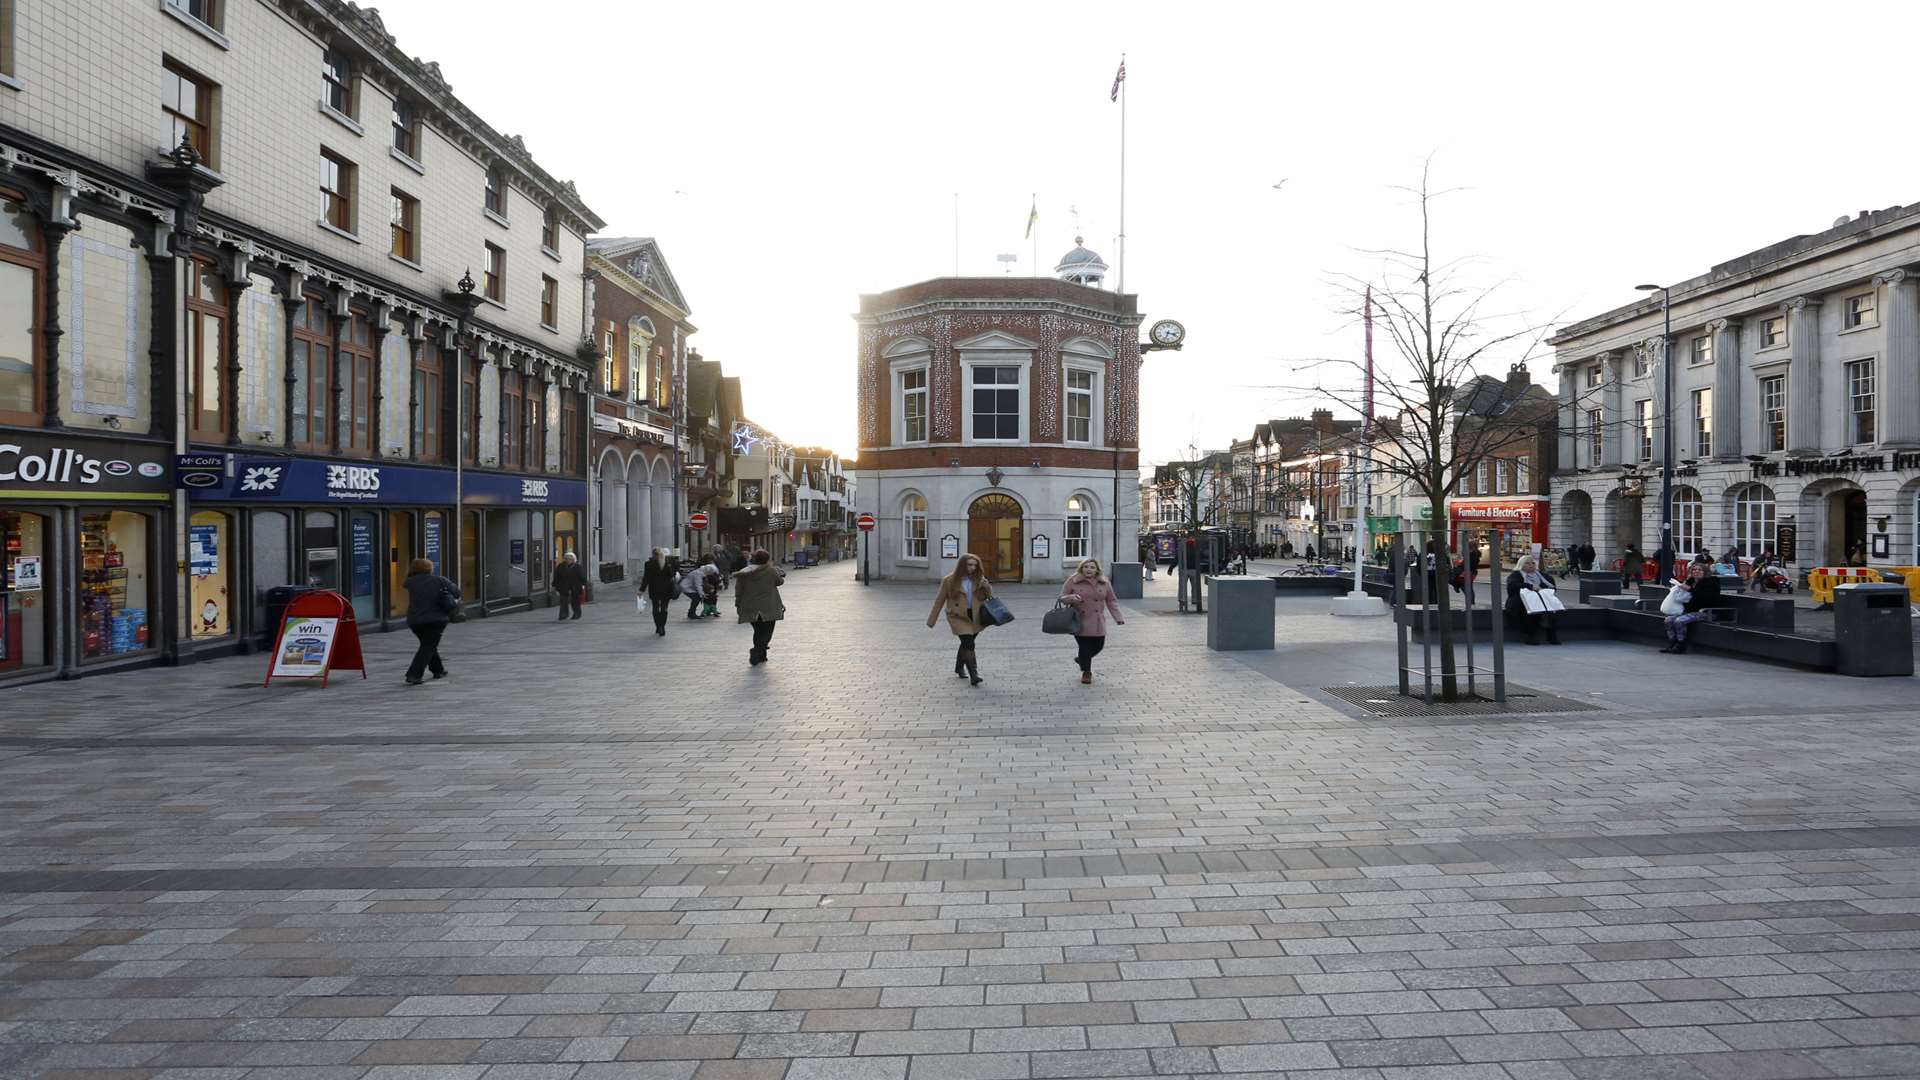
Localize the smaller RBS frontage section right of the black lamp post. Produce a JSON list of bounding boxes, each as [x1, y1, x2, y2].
[[461, 473, 588, 613]]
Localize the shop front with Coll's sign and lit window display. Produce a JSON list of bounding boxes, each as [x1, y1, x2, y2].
[[0, 430, 173, 682]]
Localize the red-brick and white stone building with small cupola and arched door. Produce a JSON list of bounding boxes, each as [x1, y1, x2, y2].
[[854, 238, 1140, 582]]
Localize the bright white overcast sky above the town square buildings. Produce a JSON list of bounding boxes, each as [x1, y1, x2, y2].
[[380, 0, 1920, 465]]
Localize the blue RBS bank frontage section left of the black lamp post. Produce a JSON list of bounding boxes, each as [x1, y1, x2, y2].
[[182, 454, 453, 638]]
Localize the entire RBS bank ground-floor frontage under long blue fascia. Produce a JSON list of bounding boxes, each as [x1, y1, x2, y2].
[[175, 454, 588, 644]]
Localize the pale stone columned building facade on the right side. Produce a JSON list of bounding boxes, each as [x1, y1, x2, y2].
[[1551, 206, 1920, 569]]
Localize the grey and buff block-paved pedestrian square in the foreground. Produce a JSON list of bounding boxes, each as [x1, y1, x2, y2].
[[0, 567, 1920, 1080]]
